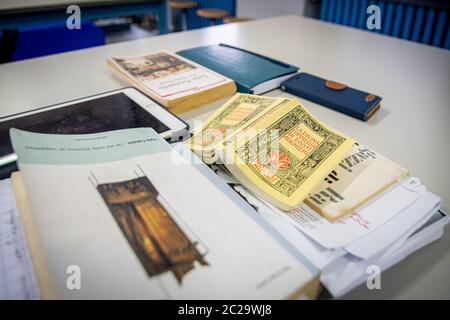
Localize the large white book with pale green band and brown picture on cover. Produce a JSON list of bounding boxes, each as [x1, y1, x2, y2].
[[7, 128, 317, 299]]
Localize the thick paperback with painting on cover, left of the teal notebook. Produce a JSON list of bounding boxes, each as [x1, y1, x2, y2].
[[107, 51, 236, 113]]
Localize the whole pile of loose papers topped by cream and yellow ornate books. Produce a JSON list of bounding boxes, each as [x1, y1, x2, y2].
[[188, 94, 448, 296]]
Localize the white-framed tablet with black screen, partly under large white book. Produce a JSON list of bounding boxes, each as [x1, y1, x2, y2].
[[0, 88, 189, 166]]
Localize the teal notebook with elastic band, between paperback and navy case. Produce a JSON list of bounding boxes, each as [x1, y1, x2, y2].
[[177, 44, 298, 94]]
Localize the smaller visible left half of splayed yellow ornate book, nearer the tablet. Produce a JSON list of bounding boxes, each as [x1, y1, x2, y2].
[[186, 93, 286, 158]]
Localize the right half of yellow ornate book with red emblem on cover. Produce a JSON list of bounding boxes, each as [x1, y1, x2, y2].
[[222, 99, 354, 211]]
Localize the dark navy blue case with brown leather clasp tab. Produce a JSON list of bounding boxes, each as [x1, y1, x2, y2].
[[281, 72, 382, 121]]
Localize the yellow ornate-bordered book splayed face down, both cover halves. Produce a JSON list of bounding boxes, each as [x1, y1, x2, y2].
[[186, 94, 354, 210]]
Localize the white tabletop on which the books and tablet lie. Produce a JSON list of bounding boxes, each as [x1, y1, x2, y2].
[[0, 16, 450, 299]]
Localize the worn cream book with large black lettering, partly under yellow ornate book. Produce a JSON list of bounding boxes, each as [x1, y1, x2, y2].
[[305, 143, 409, 222]]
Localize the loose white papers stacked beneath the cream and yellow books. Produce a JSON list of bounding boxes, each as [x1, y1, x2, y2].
[[213, 166, 449, 296]]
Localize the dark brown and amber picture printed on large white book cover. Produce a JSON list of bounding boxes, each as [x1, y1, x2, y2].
[[97, 177, 208, 285]]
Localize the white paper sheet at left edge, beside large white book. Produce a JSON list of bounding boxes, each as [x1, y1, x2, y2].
[[0, 179, 39, 300]]
